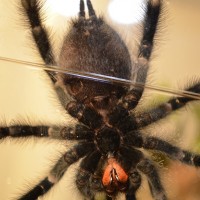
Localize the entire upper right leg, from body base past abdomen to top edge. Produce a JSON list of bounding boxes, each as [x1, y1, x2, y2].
[[109, 0, 162, 134]]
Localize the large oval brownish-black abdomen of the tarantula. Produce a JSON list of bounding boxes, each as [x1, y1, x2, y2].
[[57, 17, 132, 106]]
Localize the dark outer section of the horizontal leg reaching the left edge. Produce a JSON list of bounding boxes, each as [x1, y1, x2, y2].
[[0, 126, 49, 139]]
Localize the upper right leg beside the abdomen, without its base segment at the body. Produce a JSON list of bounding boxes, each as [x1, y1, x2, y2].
[[125, 0, 162, 110]]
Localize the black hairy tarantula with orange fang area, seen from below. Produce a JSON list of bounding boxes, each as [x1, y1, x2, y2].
[[0, 0, 200, 200]]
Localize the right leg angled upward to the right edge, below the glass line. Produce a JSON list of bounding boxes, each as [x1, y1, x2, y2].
[[109, 83, 200, 133]]
